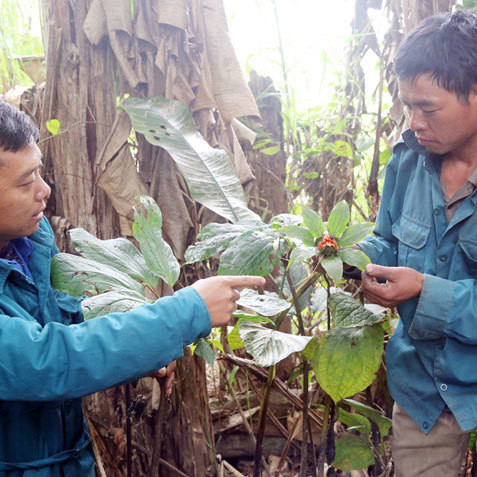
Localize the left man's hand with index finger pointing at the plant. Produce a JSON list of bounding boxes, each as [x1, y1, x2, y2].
[[192, 275, 265, 326]]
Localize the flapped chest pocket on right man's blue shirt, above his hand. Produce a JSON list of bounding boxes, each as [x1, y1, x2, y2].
[[392, 214, 431, 272]]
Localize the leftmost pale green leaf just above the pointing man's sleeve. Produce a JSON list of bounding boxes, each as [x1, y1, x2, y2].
[[51, 253, 144, 296]]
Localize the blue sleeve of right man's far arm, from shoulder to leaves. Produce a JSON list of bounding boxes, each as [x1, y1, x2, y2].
[[358, 152, 399, 267]]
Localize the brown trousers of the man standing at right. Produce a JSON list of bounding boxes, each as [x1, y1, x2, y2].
[[392, 403, 470, 477]]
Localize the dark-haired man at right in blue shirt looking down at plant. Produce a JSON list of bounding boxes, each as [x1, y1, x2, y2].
[[359, 11, 477, 477]]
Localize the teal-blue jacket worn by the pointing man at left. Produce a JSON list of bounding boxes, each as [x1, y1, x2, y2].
[[0, 219, 211, 477]]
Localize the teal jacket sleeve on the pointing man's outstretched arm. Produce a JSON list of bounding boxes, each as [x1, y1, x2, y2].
[[0, 287, 211, 401]]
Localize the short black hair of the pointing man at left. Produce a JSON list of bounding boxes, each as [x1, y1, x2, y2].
[[0, 100, 40, 152]]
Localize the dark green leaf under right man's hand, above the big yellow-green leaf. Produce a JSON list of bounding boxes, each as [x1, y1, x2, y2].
[[329, 293, 383, 328]]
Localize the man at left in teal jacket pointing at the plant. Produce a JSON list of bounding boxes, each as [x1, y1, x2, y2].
[[0, 101, 264, 477]]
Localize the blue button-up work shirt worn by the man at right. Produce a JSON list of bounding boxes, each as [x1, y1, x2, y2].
[[359, 131, 477, 433]]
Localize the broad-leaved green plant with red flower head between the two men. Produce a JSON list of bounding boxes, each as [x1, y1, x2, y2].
[[186, 202, 386, 475]]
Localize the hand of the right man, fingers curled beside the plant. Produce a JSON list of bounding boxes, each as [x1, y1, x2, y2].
[[361, 264, 424, 308]]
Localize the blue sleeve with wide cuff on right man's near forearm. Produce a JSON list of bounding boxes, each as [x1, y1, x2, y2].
[[409, 275, 477, 345]]
